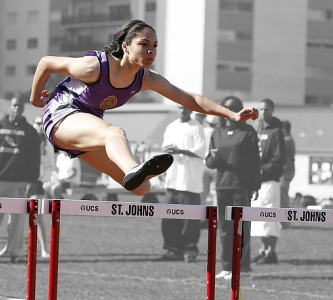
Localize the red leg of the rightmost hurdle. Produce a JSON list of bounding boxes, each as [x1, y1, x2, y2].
[[230, 207, 243, 300]]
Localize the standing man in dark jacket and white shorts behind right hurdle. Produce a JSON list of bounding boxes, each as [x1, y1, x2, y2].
[[251, 99, 285, 264]]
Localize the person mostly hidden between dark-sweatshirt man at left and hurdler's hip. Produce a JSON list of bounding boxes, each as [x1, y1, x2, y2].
[[30, 116, 56, 258]]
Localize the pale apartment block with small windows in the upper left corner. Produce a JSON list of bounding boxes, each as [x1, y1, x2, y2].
[[0, 0, 50, 99]]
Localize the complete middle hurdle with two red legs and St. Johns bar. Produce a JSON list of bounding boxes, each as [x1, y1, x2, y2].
[[41, 199, 218, 300]]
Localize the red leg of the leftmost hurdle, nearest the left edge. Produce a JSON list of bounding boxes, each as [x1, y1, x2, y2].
[[26, 200, 38, 300]]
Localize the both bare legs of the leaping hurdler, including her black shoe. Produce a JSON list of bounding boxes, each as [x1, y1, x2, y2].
[[53, 113, 173, 195]]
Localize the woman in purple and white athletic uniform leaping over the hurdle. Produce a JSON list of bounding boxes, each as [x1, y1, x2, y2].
[[30, 20, 258, 196]]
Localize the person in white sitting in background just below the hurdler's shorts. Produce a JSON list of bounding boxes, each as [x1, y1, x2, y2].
[[43, 151, 81, 199]]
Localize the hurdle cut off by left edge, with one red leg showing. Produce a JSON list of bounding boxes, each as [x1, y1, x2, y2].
[[0, 198, 38, 300]]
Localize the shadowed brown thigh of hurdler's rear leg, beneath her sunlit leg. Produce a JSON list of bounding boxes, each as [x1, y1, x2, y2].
[[78, 149, 125, 185]]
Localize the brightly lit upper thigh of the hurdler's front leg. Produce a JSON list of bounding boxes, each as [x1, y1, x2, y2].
[[52, 113, 119, 151]]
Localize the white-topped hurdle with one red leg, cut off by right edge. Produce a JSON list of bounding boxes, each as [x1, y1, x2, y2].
[[225, 206, 333, 300]]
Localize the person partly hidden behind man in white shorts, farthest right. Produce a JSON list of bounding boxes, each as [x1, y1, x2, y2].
[[280, 120, 296, 228]]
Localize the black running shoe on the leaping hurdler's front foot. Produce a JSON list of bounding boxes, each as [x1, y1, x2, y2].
[[123, 154, 173, 191]]
